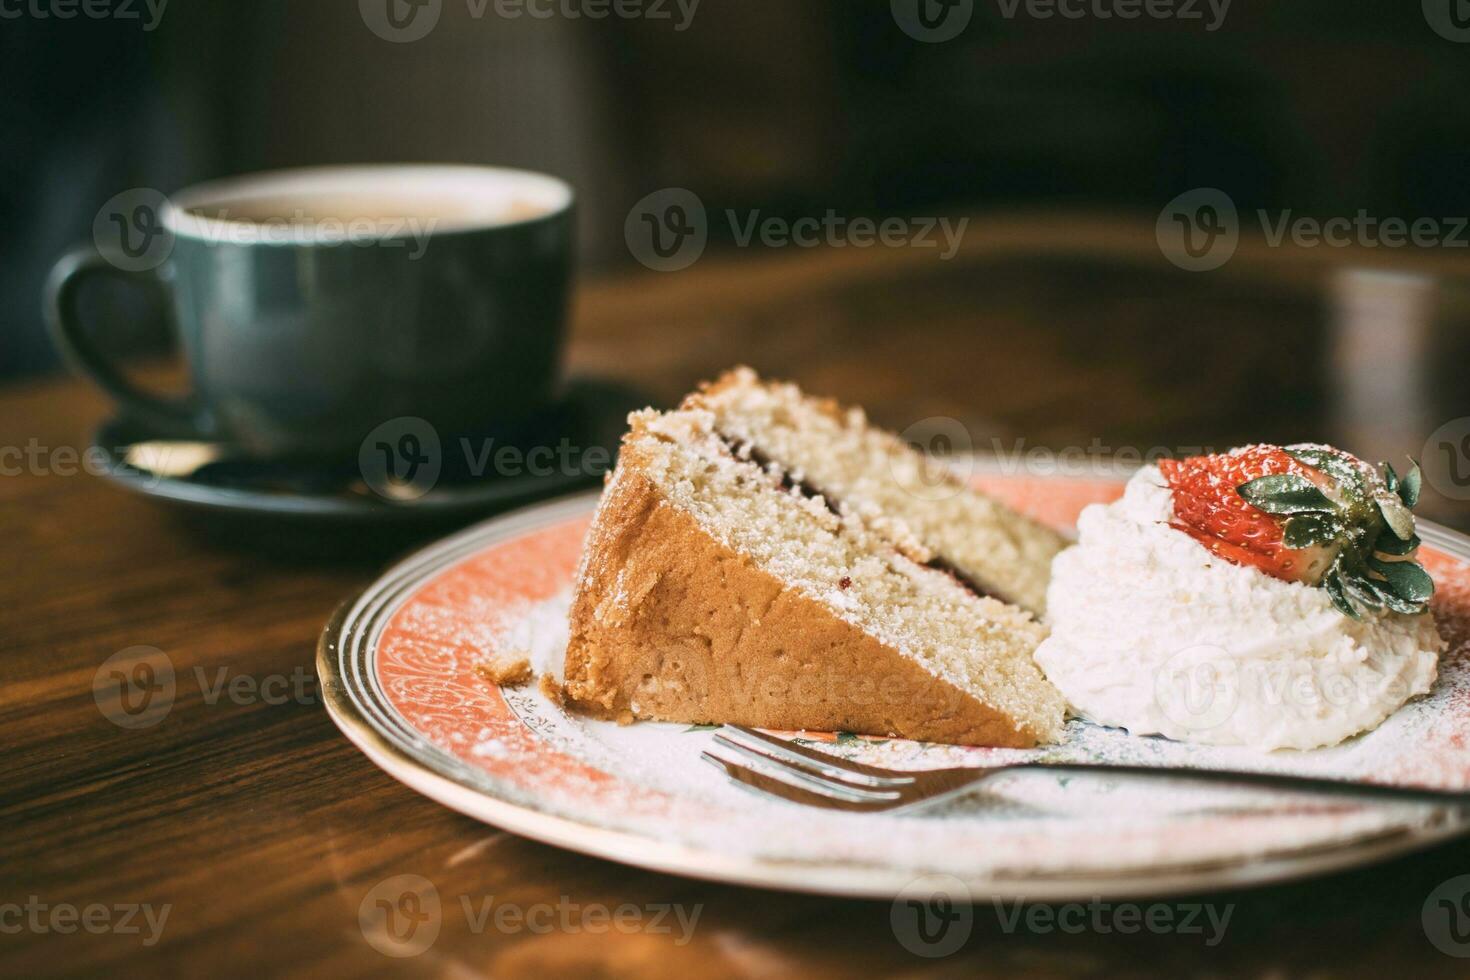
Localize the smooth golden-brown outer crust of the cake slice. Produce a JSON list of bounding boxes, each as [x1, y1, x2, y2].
[[564, 444, 1048, 748]]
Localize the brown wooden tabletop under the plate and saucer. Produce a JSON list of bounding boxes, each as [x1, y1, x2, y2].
[[0, 216, 1470, 977]]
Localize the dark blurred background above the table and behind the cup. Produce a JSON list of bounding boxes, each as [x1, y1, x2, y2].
[[0, 0, 1470, 376]]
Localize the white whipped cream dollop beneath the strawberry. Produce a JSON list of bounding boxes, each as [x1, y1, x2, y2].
[[1036, 466, 1445, 749]]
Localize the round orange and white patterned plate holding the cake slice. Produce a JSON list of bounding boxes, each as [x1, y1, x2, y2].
[[318, 472, 1470, 901]]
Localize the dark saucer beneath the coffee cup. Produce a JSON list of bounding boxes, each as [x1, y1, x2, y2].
[[93, 378, 648, 522]]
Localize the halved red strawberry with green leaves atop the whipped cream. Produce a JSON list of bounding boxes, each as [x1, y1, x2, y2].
[[1158, 445, 1433, 619]]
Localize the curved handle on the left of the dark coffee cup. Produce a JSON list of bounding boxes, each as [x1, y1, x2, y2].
[[46, 248, 207, 438]]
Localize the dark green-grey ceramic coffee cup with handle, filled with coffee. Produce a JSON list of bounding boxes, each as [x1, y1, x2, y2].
[[47, 165, 573, 455]]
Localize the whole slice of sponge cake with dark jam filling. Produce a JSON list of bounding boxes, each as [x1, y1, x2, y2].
[[564, 372, 1064, 746]]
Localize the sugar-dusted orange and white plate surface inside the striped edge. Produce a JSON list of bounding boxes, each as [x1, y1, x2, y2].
[[364, 479, 1470, 879]]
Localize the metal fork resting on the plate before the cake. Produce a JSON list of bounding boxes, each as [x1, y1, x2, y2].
[[701, 724, 1470, 813]]
